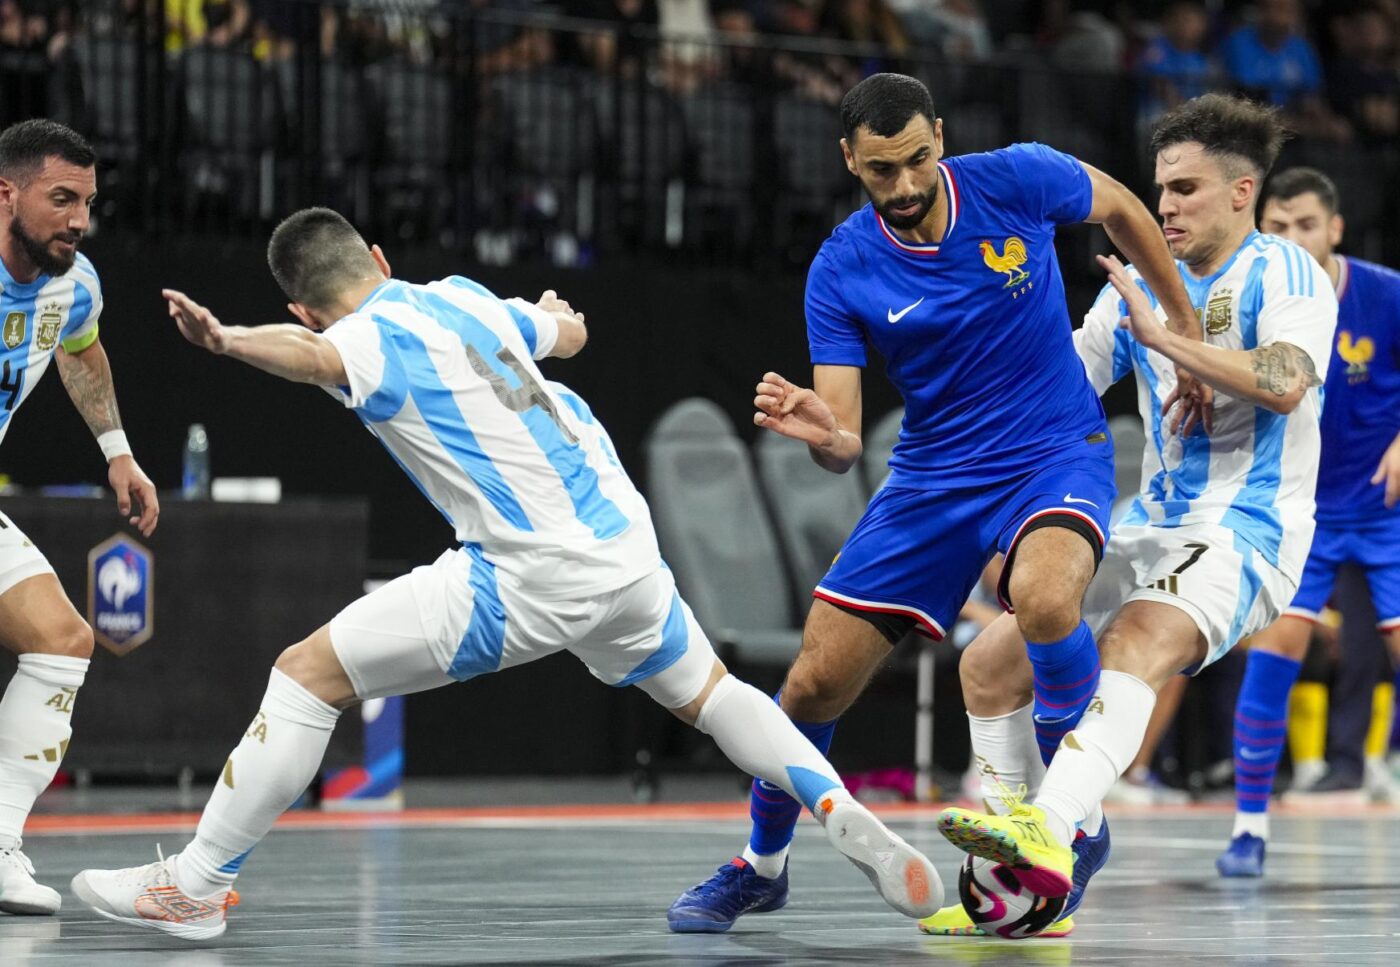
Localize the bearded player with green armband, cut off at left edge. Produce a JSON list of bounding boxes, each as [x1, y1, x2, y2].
[[0, 119, 160, 915]]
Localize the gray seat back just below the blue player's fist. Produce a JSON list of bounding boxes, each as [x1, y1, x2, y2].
[[755, 431, 865, 614]]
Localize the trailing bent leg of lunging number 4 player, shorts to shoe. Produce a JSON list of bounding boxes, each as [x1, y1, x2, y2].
[[73, 554, 464, 940]]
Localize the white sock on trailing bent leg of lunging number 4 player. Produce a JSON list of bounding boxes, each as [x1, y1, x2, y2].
[[175, 669, 340, 897]]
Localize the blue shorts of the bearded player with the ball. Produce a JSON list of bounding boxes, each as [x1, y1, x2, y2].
[[812, 444, 1116, 640]]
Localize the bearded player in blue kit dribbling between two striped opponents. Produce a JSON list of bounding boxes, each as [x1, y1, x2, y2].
[[668, 74, 1201, 932]]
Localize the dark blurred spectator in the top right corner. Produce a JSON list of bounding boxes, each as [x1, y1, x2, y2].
[[1327, 4, 1400, 143]]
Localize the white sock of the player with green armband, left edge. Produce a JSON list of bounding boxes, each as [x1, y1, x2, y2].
[[0, 654, 88, 849]]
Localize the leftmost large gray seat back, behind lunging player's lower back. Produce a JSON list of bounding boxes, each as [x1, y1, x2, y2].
[[645, 399, 802, 665]]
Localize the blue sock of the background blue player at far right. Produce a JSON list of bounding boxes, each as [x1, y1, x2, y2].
[[1235, 651, 1302, 813]]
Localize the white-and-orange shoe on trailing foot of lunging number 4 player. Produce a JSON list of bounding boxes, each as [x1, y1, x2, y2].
[[73, 856, 238, 940]]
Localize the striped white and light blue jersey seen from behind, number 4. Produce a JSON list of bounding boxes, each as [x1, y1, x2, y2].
[[325, 276, 661, 598]]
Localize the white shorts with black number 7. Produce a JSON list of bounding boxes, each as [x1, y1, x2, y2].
[[1084, 523, 1296, 672]]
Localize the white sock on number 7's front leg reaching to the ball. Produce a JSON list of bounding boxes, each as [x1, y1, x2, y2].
[[1035, 670, 1156, 845]]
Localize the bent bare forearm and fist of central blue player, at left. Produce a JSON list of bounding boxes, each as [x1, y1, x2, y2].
[[753, 365, 861, 473]]
